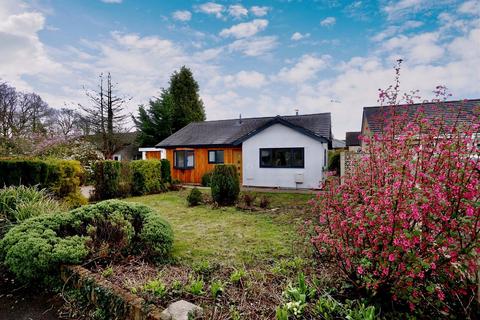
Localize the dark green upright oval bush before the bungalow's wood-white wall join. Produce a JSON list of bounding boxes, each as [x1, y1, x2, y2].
[[210, 164, 240, 205]]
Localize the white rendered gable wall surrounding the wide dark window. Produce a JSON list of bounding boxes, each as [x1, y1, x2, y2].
[[242, 124, 328, 189]]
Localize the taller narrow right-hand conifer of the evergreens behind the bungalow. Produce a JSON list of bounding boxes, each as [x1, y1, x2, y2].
[[169, 66, 206, 132]]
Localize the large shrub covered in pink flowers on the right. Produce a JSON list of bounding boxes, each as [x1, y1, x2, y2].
[[311, 106, 480, 312]]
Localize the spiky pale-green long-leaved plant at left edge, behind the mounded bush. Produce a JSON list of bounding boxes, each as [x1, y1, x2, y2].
[[0, 186, 62, 223]]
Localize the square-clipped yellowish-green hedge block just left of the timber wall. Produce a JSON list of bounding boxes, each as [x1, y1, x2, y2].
[[130, 160, 166, 195]]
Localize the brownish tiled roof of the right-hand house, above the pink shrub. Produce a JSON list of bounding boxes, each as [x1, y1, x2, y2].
[[364, 99, 480, 132]]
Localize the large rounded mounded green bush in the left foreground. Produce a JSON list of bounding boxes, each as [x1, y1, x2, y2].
[[0, 200, 173, 282]]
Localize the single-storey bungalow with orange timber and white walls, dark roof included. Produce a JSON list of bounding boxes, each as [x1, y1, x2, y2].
[[156, 113, 332, 189]]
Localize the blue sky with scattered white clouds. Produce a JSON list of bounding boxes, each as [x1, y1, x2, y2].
[[0, 0, 480, 139]]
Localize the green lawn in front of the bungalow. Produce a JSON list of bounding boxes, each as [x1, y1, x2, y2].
[[127, 191, 312, 266]]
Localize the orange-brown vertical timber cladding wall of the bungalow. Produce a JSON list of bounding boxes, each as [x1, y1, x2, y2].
[[167, 147, 242, 184]]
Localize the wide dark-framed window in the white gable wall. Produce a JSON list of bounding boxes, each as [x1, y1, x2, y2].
[[260, 148, 305, 168]]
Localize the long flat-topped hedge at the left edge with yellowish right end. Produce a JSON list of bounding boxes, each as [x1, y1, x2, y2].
[[0, 160, 86, 205]]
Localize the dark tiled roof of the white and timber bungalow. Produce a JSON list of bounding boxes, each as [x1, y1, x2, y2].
[[156, 113, 331, 148]]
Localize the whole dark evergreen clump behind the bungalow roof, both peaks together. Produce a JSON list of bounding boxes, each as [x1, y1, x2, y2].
[[133, 66, 205, 146]]
